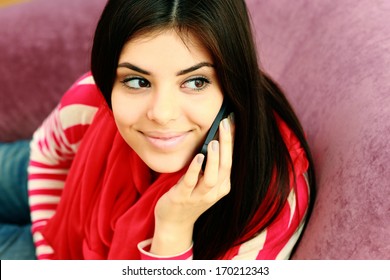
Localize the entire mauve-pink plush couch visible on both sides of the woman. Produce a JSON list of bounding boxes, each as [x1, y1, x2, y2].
[[0, 0, 390, 259]]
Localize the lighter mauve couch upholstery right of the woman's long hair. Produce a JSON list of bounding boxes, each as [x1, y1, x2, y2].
[[247, 0, 390, 259]]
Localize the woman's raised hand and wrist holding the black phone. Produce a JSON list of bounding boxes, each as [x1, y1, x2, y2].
[[151, 118, 234, 255]]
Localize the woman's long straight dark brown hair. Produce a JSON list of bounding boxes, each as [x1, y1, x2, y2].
[[91, 0, 315, 259]]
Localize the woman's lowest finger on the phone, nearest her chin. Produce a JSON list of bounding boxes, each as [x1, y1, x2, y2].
[[176, 154, 204, 195]]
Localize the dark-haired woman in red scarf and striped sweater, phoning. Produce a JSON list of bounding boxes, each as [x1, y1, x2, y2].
[[9, 0, 315, 259]]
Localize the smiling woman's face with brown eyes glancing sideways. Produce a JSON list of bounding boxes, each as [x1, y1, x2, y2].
[[111, 30, 223, 173]]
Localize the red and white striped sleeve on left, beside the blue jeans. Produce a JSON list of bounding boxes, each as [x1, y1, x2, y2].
[[28, 74, 103, 259]]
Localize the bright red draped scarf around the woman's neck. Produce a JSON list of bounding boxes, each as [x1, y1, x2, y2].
[[43, 105, 186, 259]]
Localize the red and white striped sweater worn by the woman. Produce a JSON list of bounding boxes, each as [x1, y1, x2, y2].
[[28, 73, 309, 259]]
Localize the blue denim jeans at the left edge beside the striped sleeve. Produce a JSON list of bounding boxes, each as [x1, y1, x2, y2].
[[0, 140, 36, 260]]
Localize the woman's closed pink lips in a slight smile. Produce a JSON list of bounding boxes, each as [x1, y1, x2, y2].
[[141, 132, 188, 150]]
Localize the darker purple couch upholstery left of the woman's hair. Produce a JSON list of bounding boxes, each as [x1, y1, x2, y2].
[[0, 0, 106, 141]]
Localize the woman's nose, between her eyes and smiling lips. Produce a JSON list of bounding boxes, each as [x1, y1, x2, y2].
[[147, 88, 180, 125]]
